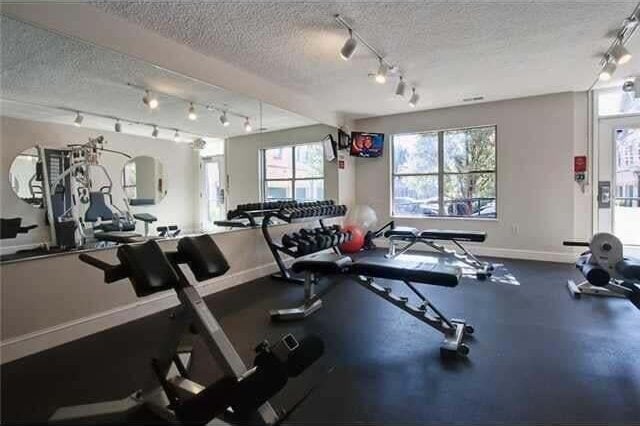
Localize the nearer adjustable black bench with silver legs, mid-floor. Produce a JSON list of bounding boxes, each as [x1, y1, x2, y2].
[[271, 253, 474, 357]]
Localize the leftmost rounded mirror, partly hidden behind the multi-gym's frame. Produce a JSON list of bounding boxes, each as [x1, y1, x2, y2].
[[9, 147, 43, 209]]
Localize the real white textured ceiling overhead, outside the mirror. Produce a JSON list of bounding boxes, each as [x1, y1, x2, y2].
[[95, 0, 640, 118]]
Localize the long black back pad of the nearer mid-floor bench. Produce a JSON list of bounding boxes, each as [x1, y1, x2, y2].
[[351, 259, 462, 287]]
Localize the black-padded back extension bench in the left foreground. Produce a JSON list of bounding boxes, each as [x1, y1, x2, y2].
[[50, 235, 324, 425]]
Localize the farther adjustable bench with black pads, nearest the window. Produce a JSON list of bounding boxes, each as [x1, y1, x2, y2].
[[384, 226, 495, 280]]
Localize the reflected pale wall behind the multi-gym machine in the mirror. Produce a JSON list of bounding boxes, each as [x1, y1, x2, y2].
[[0, 117, 199, 251]]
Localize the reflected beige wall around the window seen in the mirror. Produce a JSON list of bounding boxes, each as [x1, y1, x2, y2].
[[225, 124, 339, 209]]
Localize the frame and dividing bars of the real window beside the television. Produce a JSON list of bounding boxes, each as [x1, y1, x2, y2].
[[388, 124, 500, 222]]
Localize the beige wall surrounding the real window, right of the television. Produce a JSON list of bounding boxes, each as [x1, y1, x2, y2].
[[355, 93, 591, 261]]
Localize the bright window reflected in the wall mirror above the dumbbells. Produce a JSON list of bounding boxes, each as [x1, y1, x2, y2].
[[262, 143, 324, 201]]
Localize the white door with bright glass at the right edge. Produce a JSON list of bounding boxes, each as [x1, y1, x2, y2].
[[596, 117, 640, 246]]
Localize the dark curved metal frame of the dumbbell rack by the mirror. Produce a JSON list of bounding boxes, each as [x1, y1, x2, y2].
[[262, 206, 344, 284]]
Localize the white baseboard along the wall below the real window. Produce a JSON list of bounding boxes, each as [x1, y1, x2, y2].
[[376, 239, 577, 263]]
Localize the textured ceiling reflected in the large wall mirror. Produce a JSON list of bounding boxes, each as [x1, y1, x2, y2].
[[0, 16, 315, 138]]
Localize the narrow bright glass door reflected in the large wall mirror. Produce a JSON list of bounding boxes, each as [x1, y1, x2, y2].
[[200, 155, 227, 230]]
